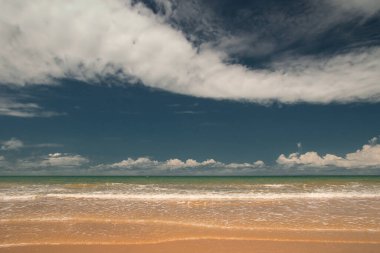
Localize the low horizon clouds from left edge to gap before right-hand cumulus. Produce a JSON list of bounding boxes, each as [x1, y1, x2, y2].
[[0, 153, 267, 175]]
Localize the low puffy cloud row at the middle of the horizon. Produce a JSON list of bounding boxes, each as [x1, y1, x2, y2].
[[95, 157, 265, 175]]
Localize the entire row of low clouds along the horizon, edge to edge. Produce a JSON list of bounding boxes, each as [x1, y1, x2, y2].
[[0, 137, 380, 176]]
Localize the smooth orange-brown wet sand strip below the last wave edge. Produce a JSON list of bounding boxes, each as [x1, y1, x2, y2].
[[0, 239, 380, 253]]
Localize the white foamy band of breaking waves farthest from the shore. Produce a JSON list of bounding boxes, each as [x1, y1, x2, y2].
[[0, 183, 380, 202]]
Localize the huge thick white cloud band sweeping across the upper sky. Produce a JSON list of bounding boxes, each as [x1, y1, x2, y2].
[[0, 0, 380, 103]]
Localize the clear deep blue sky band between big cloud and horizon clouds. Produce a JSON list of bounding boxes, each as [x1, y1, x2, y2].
[[0, 80, 380, 171]]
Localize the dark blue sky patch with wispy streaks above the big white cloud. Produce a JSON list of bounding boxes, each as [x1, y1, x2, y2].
[[159, 0, 380, 58]]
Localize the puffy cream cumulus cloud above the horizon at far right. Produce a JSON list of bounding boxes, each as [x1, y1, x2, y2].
[[277, 138, 380, 169]]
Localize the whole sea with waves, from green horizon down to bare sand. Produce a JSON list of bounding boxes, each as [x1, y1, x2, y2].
[[0, 176, 380, 247]]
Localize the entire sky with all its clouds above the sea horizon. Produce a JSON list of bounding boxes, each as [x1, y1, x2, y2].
[[0, 0, 380, 175]]
